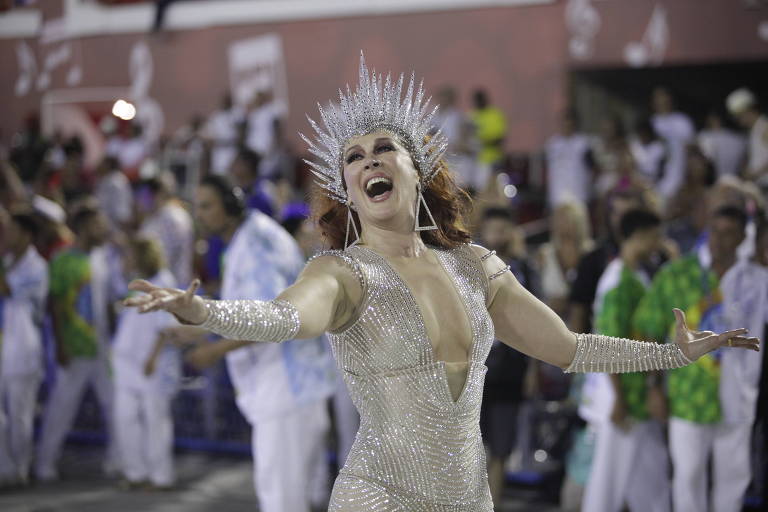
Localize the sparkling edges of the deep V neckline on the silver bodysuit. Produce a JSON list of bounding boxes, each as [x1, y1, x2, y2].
[[357, 245, 477, 405]]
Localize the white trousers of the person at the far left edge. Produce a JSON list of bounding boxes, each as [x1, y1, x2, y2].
[[0, 374, 41, 481]]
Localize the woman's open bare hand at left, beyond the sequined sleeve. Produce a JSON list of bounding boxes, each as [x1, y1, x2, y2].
[[123, 279, 208, 324]]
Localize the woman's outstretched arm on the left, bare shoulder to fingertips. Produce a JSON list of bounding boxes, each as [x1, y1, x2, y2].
[[125, 256, 362, 342]]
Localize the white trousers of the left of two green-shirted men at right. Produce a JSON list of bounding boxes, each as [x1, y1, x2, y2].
[[581, 421, 671, 512]]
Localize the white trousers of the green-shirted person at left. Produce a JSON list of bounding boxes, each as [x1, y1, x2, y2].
[[35, 357, 120, 479]]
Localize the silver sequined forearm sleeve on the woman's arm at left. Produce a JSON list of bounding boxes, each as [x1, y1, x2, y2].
[[200, 300, 300, 343]]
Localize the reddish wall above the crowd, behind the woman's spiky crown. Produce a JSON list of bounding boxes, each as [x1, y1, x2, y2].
[[0, 5, 566, 149]]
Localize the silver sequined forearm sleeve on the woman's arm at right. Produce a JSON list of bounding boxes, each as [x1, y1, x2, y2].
[[565, 334, 692, 373]]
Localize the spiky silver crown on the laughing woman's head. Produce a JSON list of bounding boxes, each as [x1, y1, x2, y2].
[[299, 52, 448, 204]]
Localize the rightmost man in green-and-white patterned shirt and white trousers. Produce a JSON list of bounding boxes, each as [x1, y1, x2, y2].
[[634, 206, 766, 512]]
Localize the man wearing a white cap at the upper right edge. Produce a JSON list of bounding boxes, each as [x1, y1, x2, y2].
[[725, 88, 768, 185]]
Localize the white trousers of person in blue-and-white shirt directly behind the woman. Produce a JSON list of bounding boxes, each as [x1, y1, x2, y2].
[[252, 400, 328, 512]]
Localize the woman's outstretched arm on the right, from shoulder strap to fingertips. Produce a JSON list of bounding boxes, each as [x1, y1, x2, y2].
[[473, 246, 759, 373]]
